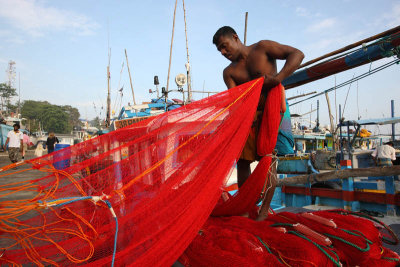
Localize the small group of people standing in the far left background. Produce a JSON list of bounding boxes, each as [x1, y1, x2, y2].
[[3, 123, 60, 163]]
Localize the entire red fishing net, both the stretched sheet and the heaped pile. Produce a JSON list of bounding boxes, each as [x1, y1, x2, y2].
[[0, 79, 399, 266]]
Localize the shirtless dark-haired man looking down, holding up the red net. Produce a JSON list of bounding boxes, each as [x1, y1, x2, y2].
[[213, 26, 304, 216]]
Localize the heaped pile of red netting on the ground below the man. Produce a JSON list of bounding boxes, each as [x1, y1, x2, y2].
[[183, 210, 400, 267]]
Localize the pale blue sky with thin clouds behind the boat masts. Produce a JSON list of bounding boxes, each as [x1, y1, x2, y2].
[[0, 0, 400, 134]]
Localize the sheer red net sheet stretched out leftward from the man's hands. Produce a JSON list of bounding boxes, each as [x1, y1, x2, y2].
[[0, 79, 265, 266]]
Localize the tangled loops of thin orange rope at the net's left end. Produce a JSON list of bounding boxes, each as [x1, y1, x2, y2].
[[0, 161, 97, 266]]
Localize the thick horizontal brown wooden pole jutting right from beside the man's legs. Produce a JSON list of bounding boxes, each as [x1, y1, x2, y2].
[[278, 165, 400, 186]]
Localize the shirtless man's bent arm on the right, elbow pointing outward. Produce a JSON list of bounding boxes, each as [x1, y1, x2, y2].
[[261, 40, 304, 87]]
